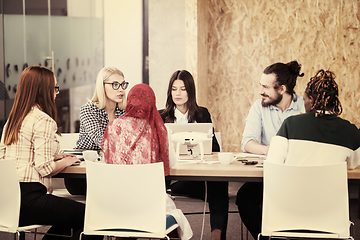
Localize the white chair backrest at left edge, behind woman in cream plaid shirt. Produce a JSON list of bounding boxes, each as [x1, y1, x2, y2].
[[0, 159, 20, 233]]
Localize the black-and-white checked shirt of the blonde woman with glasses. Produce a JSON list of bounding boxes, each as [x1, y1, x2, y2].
[[76, 102, 125, 150]]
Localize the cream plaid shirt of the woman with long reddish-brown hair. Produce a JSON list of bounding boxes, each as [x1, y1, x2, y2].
[[0, 106, 59, 190]]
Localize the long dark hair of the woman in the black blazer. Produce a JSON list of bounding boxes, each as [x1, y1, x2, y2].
[[162, 70, 202, 123]]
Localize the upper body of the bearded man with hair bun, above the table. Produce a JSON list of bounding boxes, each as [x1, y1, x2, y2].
[[241, 61, 305, 155]]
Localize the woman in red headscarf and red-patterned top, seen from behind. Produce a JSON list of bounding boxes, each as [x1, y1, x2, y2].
[[101, 84, 192, 239]]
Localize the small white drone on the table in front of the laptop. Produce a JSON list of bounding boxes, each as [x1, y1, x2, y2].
[[171, 129, 213, 162]]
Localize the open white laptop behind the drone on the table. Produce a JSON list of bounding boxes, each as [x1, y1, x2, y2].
[[165, 123, 213, 155]]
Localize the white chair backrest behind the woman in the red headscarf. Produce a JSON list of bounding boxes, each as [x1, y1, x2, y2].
[[84, 161, 166, 238]]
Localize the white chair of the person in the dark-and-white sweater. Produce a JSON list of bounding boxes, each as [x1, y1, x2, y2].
[[259, 161, 352, 239]]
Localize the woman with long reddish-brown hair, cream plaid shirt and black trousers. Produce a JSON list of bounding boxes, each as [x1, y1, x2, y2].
[[0, 66, 103, 240]]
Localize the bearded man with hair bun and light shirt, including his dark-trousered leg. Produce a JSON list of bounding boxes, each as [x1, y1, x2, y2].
[[236, 61, 305, 239]]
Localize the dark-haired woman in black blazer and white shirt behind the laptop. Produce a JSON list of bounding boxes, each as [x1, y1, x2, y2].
[[159, 70, 229, 240]]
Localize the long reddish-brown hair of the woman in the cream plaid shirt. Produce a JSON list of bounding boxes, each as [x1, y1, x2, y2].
[[4, 66, 59, 145]]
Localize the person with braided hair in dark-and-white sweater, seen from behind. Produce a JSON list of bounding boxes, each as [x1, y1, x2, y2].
[[267, 70, 360, 169]]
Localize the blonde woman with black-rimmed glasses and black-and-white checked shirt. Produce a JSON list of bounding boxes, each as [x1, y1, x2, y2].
[[64, 67, 129, 195]]
